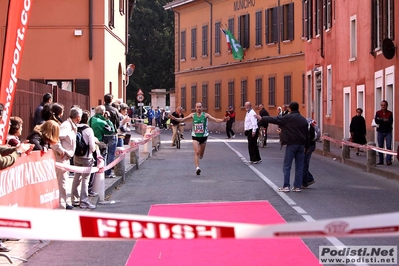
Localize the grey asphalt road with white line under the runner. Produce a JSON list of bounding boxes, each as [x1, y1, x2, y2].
[[24, 131, 399, 266]]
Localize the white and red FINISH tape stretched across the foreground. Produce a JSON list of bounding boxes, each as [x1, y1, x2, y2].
[[0, 206, 399, 241]]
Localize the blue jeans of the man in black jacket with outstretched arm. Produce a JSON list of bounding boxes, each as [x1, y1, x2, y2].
[[283, 144, 305, 188]]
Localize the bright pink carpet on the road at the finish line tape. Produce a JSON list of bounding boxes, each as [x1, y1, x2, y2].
[[126, 201, 320, 266]]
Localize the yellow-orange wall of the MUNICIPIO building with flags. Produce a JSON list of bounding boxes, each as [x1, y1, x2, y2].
[[175, 0, 305, 125]]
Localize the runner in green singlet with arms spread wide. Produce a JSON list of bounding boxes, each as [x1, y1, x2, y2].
[[169, 102, 229, 175]]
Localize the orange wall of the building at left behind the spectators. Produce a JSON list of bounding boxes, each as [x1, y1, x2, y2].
[[0, 0, 126, 107]]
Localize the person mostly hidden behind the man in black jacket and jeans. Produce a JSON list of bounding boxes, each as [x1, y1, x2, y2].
[[302, 118, 320, 188]]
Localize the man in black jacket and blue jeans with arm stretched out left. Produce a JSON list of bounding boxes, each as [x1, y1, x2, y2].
[[257, 102, 309, 192]]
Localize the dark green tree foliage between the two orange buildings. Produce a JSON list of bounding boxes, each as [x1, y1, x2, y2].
[[126, 0, 174, 106]]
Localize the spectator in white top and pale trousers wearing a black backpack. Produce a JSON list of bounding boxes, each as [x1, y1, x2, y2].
[[71, 111, 96, 209]]
